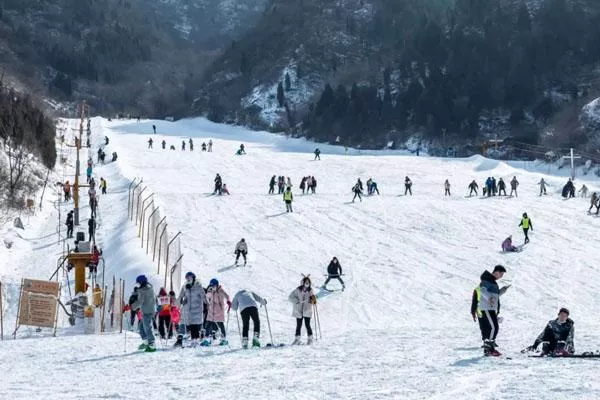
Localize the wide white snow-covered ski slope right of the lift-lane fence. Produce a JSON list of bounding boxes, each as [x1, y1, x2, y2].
[[0, 119, 600, 399]]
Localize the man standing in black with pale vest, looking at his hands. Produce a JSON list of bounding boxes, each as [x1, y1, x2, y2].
[[471, 265, 510, 356]]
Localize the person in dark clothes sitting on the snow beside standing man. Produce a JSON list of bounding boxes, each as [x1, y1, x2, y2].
[[526, 307, 575, 356]]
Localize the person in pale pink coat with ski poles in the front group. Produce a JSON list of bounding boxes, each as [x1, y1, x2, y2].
[[200, 278, 231, 346]]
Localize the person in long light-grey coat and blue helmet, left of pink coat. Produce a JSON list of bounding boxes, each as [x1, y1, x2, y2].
[[175, 272, 206, 347]]
